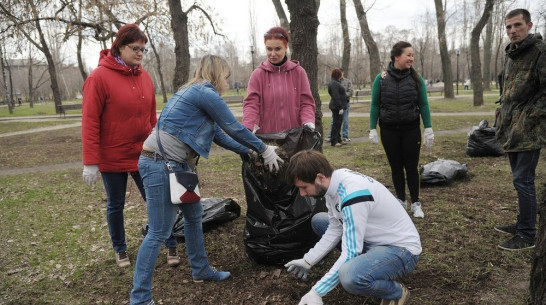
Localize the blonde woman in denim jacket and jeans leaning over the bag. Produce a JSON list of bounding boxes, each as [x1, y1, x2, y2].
[[131, 55, 282, 304]]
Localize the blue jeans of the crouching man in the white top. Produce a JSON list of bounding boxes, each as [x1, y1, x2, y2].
[[311, 212, 419, 300]]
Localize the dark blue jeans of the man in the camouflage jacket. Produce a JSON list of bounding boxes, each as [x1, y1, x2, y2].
[[507, 149, 540, 241]]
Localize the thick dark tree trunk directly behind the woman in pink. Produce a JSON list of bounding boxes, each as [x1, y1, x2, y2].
[[286, 0, 323, 149]]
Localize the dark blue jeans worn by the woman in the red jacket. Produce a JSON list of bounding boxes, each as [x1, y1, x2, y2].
[[101, 172, 177, 253]]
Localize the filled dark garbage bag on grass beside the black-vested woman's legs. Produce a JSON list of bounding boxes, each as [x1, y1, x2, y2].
[[419, 159, 468, 185]]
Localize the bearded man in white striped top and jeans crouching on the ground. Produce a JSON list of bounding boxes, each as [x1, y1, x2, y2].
[[285, 150, 422, 305]]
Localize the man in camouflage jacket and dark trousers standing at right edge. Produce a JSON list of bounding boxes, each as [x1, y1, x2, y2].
[[495, 9, 546, 250]]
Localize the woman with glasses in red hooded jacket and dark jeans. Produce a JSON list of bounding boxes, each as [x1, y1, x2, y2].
[[82, 24, 179, 267]]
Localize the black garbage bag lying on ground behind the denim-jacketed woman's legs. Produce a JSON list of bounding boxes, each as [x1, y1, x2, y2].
[[142, 198, 241, 240]]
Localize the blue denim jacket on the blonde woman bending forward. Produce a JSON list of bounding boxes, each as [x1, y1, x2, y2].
[[158, 82, 265, 158]]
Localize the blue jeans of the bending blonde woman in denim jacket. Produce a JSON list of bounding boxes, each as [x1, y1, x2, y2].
[[131, 156, 212, 305]]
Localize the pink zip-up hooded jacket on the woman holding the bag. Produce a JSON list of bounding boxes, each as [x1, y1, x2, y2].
[[243, 60, 315, 133]]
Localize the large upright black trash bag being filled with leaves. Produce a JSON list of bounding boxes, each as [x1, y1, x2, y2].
[[242, 127, 326, 265]]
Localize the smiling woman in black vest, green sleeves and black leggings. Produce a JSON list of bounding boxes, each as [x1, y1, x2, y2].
[[370, 41, 434, 218]]
